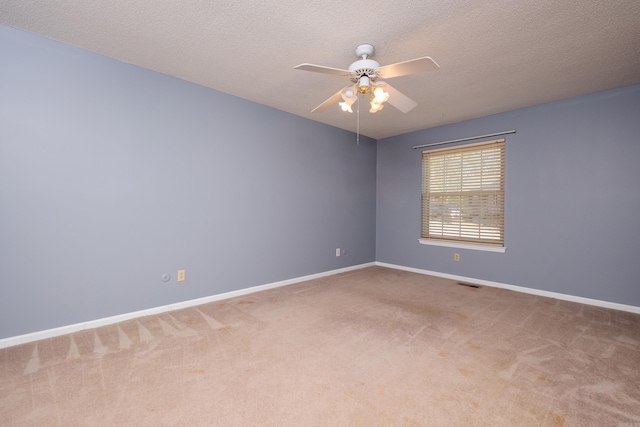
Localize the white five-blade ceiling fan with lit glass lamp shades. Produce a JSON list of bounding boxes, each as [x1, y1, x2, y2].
[[294, 44, 440, 113]]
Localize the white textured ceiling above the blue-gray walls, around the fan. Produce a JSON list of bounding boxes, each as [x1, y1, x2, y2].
[[0, 0, 640, 138]]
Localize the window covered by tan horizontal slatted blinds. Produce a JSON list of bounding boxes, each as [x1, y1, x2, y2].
[[421, 139, 505, 247]]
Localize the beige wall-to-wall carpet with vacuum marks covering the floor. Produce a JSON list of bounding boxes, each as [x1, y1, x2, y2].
[[0, 267, 640, 427]]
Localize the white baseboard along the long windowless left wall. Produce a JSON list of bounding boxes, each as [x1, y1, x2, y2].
[[0, 262, 376, 349]]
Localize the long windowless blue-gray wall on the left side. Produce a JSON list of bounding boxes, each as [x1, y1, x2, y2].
[[0, 26, 376, 338]]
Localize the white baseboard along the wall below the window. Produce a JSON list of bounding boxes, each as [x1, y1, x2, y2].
[[375, 262, 640, 314]]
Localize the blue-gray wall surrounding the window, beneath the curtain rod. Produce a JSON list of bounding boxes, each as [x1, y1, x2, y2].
[[376, 85, 640, 306]]
